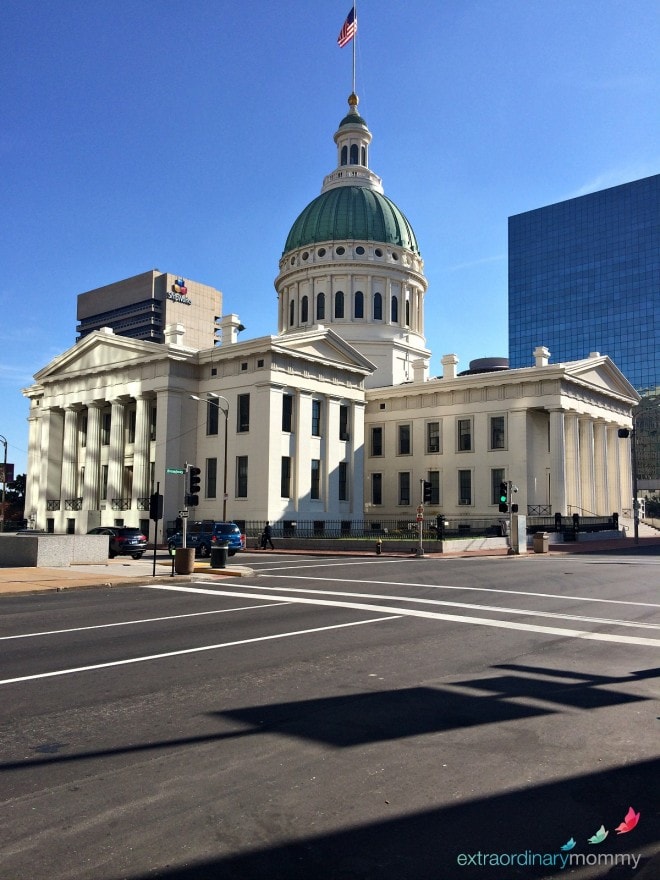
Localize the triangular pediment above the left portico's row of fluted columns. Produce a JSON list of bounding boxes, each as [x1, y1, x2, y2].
[[34, 332, 166, 382]]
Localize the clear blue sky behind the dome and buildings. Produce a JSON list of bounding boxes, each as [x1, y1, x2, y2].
[[0, 0, 660, 473]]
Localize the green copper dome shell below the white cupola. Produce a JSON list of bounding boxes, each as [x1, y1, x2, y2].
[[283, 186, 419, 255]]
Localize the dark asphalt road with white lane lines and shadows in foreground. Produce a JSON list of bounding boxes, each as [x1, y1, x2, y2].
[[0, 552, 660, 880]]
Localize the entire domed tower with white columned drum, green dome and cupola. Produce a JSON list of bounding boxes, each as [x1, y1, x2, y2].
[[275, 94, 430, 387]]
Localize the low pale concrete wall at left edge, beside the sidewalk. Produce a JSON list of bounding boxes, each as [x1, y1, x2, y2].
[[0, 533, 108, 568]]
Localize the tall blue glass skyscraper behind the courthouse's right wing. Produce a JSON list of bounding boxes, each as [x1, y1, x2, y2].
[[509, 174, 660, 393]]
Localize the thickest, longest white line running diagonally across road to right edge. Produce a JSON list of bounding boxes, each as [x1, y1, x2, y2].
[[144, 584, 660, 648]]
